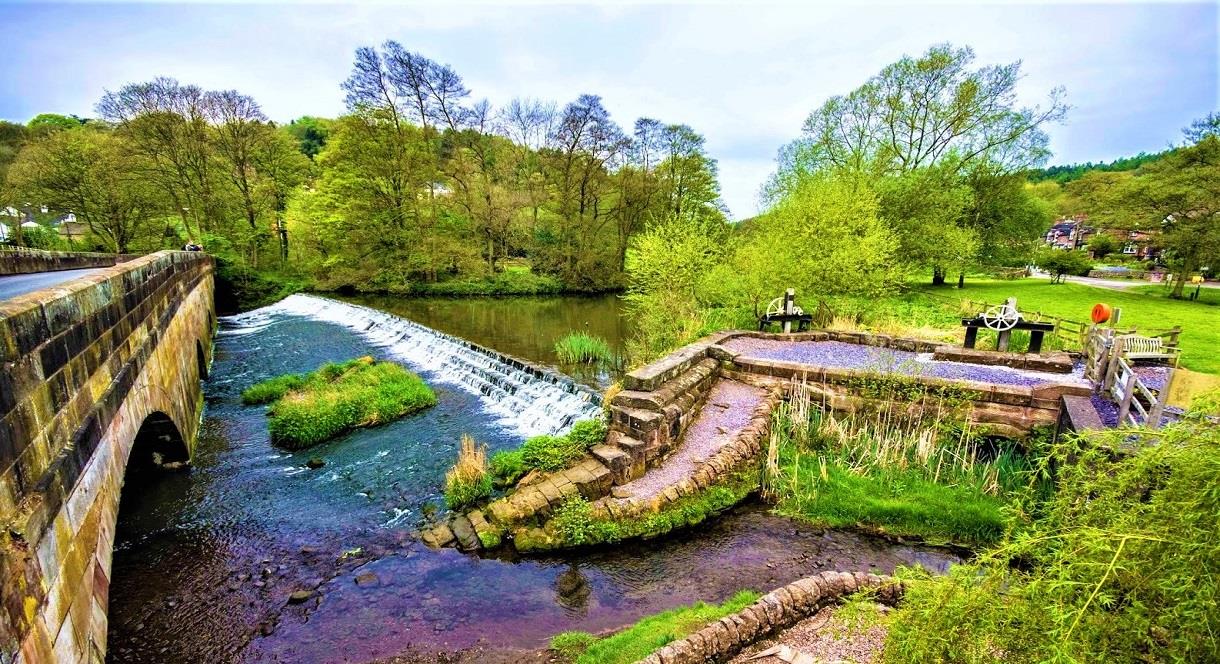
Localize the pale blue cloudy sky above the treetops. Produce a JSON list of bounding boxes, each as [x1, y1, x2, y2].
[[0, 0, 1220, 218]]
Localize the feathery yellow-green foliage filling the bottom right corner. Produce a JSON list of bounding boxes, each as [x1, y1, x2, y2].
[[885, 419, 1220, 663]]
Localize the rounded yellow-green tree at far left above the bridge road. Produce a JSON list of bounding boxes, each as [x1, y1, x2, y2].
[[9, 129, 161, 254]]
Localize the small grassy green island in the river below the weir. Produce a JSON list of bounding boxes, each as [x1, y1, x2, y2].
[[242, 358, 437, 449]]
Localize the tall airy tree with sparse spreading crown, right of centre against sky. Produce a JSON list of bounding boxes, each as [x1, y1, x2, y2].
[[767, 44, 1066, 283]]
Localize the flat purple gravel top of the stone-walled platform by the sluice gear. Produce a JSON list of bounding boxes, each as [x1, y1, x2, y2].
[[725, 337, 1082, 387]]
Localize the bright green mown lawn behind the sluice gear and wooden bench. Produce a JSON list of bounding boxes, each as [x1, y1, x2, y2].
[[916, 277, 1220, 374]]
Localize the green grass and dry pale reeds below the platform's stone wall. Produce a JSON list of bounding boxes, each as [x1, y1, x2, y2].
[[764, 378, 1031, 544]]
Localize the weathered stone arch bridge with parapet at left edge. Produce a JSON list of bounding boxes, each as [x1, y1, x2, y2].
[[0, 251, 216, 664]]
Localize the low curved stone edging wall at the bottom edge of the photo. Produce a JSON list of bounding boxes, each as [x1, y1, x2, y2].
[[636, 571, 903, 664]]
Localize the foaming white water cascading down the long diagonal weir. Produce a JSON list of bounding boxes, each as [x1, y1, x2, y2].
[[229, 294, 601, 436]]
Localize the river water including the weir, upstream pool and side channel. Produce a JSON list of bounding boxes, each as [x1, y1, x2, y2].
[[109, 295, 955, 664]]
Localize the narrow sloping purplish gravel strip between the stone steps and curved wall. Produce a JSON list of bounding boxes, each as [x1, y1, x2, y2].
[[615, 380, 766, 498]]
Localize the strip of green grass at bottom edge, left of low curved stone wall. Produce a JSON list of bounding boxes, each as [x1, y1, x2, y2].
[[551, 591, 760, 664]]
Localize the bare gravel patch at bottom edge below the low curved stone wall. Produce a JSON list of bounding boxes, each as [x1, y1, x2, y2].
[[730, 607, 886, 664]]
